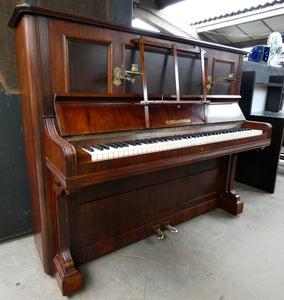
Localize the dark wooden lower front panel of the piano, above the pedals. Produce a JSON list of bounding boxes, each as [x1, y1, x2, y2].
[[71, 159, 219, 263]]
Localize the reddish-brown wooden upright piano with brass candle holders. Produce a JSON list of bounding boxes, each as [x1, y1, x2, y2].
[[9, 4, 271, 295]]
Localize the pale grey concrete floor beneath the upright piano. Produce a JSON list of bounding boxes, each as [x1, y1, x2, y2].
[[0, 174, 284, 300]]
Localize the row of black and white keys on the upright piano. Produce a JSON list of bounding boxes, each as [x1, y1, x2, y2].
[[82, 128, 262, 161]]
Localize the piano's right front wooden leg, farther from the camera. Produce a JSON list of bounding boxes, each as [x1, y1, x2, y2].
[[219, 154, 244, 215]]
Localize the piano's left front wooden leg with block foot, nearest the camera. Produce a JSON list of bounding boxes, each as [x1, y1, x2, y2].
[[53, 178, 81, 296]]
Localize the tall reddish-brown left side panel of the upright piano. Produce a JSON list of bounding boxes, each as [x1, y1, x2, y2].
[[15, 15, 56, 274]]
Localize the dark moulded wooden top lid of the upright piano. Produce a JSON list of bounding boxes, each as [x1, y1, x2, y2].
[[8, 3, 248, 55]]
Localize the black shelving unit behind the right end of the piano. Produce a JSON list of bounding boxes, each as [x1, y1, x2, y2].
[[236, 66, 284, 193]]
